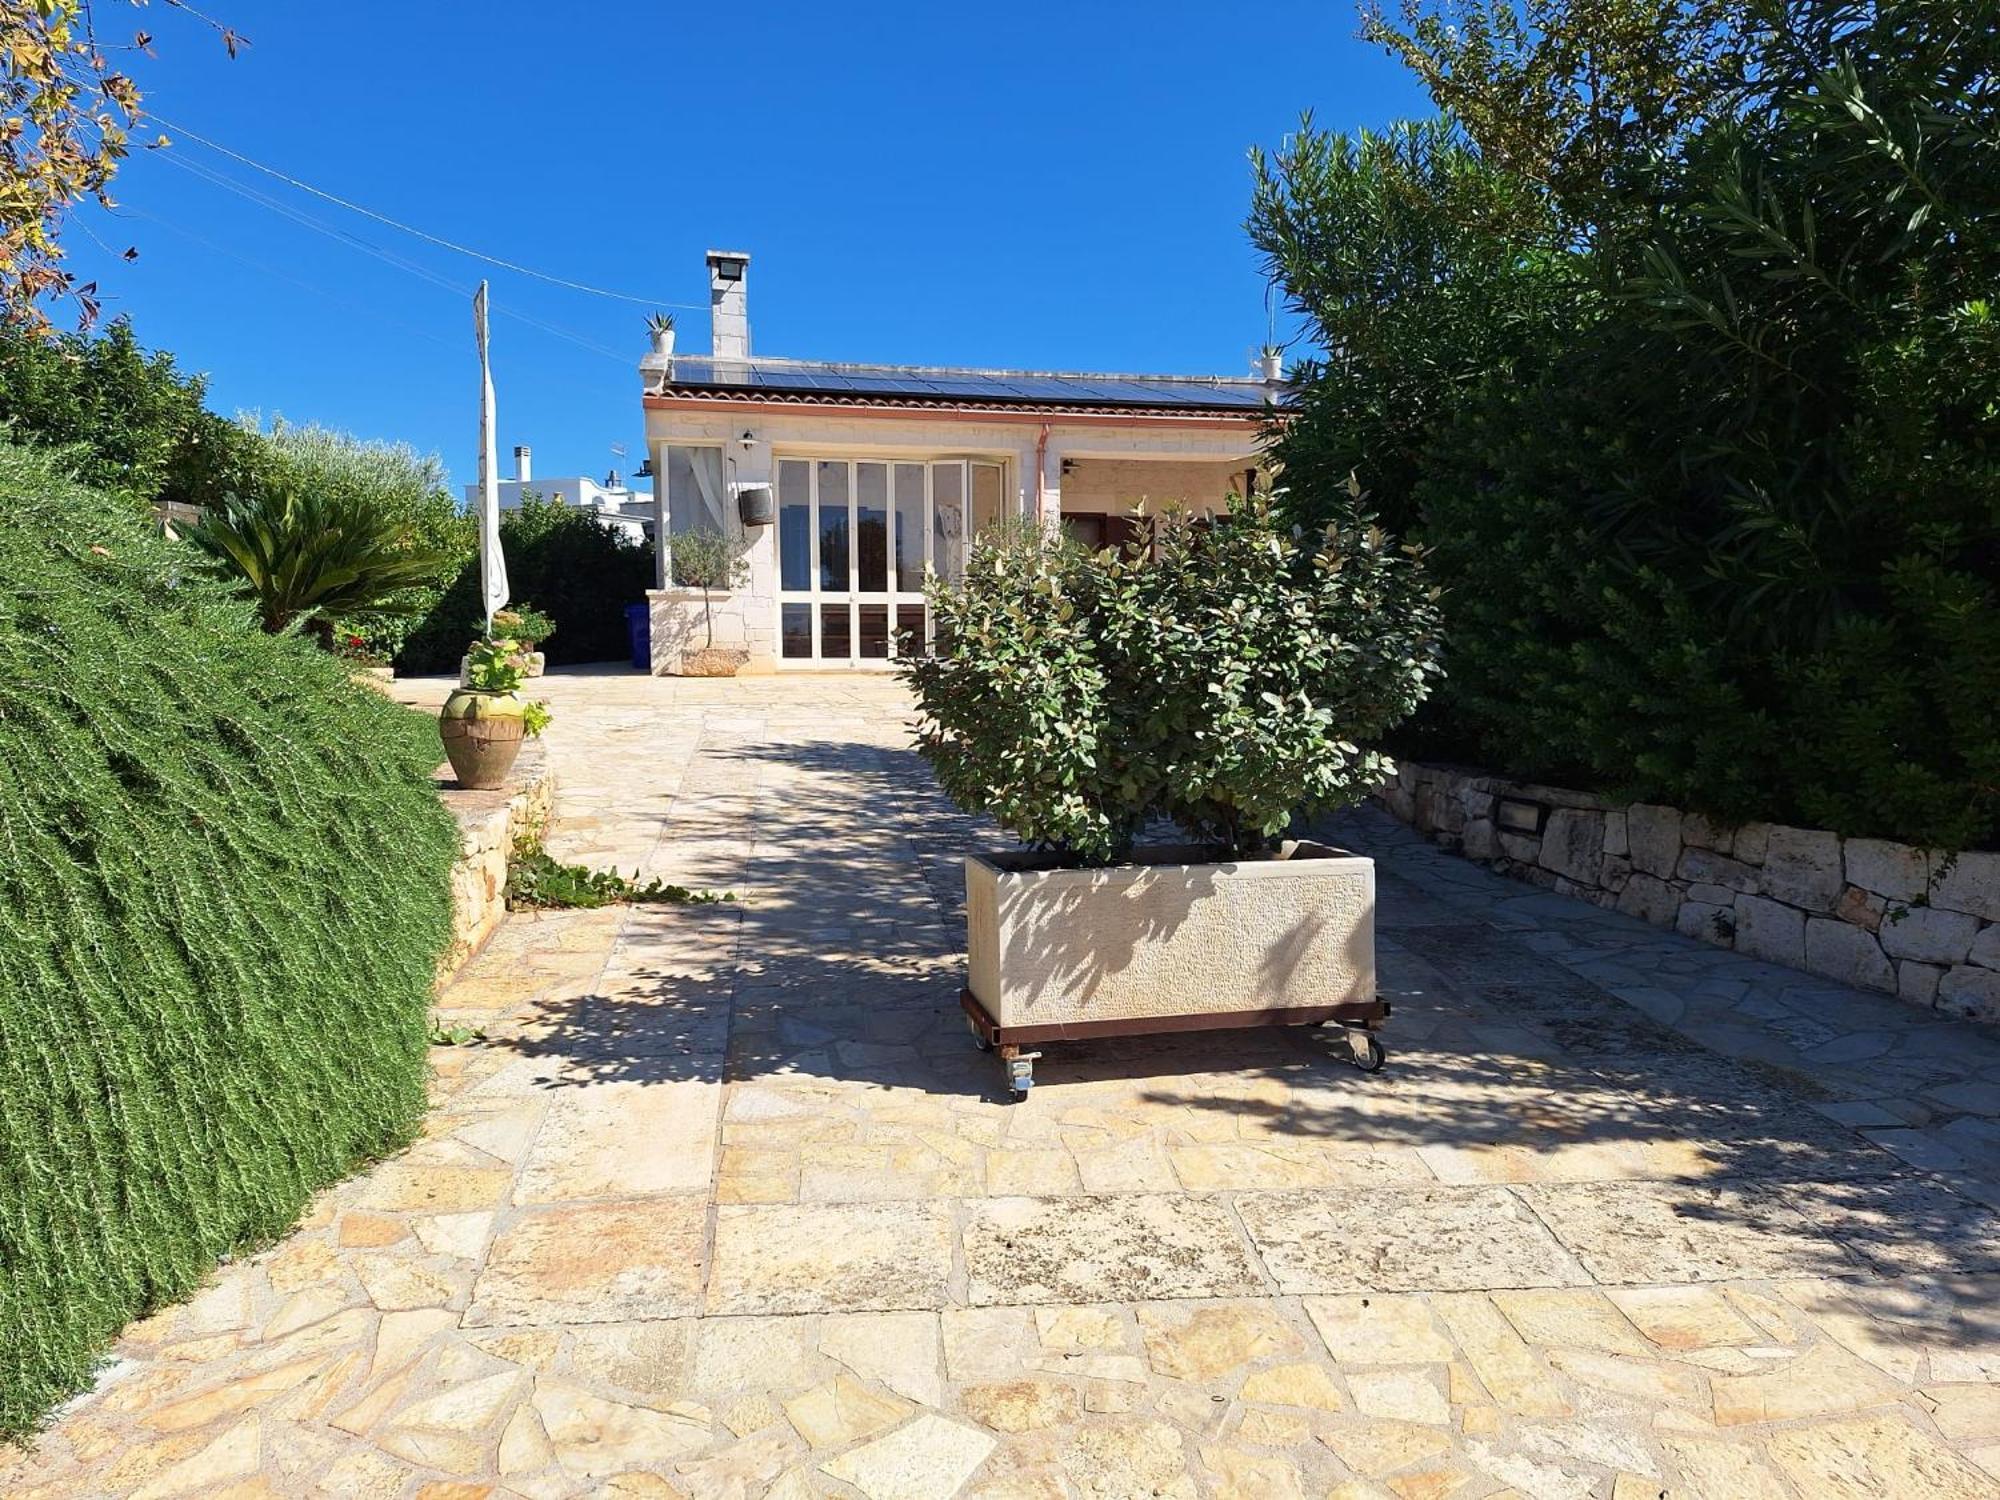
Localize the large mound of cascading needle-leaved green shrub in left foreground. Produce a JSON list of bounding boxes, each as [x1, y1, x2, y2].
[[0, 448, 458, 1436]]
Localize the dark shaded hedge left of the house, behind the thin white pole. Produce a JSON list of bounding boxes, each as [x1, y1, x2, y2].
[[396, 494, 652, 672]]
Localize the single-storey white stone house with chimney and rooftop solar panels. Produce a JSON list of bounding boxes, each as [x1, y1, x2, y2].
[[640, 250, 1284, 672]]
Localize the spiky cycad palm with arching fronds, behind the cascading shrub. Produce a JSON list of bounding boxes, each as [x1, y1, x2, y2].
[[188, 482, 444, 640]]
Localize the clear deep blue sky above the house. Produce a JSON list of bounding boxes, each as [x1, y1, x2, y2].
[[70, 0, 1426, 494]]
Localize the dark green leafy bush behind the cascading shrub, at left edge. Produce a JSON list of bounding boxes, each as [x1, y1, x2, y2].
[[0, 318, 244, 510]]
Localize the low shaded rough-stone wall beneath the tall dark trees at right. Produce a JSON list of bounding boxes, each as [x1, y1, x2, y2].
[[1376, 762, 2000, 1020]]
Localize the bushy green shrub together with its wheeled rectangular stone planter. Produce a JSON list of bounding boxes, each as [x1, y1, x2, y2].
[[900, 496, 1438, 1100]]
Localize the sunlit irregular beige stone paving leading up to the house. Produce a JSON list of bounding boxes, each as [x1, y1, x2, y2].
[[11, 674, 2000, 1500]]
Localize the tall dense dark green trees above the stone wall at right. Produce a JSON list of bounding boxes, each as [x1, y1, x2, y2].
[[1254, 0, 2000, 848]]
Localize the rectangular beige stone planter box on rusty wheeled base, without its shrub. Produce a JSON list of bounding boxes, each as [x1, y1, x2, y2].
[[960, 840, 1388, 1102]]
